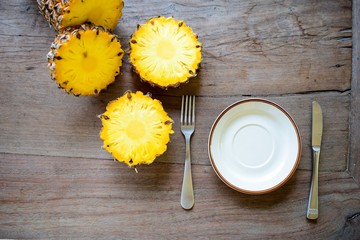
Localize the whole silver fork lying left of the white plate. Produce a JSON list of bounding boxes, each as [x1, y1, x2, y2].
[[180, 96, 195, 210]]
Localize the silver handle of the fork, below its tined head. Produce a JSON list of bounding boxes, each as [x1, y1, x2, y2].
[[181, 138, 195, 210]]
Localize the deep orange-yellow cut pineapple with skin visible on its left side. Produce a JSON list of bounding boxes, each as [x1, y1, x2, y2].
[[48, 24, 124, 96]]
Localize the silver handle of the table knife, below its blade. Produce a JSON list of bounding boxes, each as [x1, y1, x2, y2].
[[306, 147, 320, 220]]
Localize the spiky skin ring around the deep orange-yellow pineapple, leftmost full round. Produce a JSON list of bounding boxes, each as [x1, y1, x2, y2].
[[47, 24, 124, 96]]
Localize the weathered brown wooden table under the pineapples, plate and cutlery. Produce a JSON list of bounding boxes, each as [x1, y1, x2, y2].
[[0, 0, 360, 239]]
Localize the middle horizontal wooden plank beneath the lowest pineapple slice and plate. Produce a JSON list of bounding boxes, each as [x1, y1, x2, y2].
[[0, 89, 350, 171]]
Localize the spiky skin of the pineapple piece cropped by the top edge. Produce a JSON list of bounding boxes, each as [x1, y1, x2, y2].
[[37, 0, 124, 32]]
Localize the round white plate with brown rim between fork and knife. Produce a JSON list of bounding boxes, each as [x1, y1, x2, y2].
[[208, 98, 301, 194]]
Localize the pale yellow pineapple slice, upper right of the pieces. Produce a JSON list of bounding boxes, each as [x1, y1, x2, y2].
[[129, 17, 202, 88]]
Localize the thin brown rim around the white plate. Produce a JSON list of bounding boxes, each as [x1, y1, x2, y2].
[[208, 98, 302, 195]]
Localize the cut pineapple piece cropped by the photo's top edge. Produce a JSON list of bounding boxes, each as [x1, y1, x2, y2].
[[37, 0, 124, 31]]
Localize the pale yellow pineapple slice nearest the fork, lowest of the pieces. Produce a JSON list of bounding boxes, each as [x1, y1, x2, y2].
[[99, 91, 174, 167]]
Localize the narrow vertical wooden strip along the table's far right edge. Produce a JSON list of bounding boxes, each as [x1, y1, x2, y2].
[[349, 0, 360, 184]]
